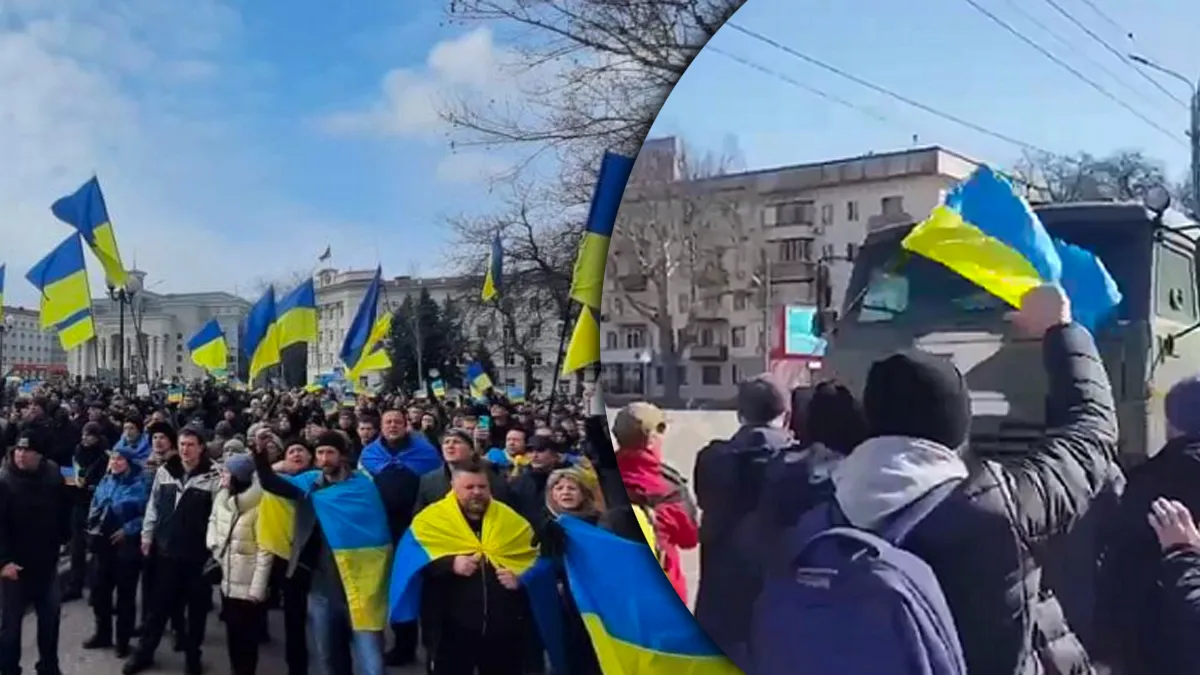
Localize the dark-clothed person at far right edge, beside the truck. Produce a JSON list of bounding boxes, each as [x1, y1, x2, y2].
[[1097, 375, 1200, 675]]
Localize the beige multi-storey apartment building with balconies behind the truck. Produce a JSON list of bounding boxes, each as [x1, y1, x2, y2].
[[601, 138, 978, 400]]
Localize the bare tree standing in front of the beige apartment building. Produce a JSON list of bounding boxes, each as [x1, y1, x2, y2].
[[605, 134, 760, 404]]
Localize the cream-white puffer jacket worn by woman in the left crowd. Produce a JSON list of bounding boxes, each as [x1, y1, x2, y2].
[[205, 480, 272, 602]]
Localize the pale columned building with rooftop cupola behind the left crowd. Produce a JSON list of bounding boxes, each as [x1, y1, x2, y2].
[[68, 270, 251, 382]]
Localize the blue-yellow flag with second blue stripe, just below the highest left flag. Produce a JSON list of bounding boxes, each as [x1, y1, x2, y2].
[[25, 233, 96, 350]]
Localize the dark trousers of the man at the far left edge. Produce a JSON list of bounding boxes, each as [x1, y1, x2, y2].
[[0, 578, 62, 675]]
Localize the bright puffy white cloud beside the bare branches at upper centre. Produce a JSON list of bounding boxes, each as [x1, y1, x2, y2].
[[318, 26, 521, 137]]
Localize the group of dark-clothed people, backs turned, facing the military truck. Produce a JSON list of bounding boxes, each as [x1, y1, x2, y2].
[[695, 281, 1200, 675]]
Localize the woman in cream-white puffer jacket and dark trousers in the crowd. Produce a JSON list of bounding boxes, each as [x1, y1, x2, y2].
[[208, 454, 271, 675]]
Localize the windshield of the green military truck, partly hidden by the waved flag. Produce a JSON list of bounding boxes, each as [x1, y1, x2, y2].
[[846, 223, 1140, 324]]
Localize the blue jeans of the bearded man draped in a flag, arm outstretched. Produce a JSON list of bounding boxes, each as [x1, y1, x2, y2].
[[308, 592, 385, 675]]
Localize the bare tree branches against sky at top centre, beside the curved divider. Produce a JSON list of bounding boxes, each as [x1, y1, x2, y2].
[[445, 0, 745, 175]]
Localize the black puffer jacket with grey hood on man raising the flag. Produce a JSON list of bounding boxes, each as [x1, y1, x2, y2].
[[806, 325, 1117, 675]]
